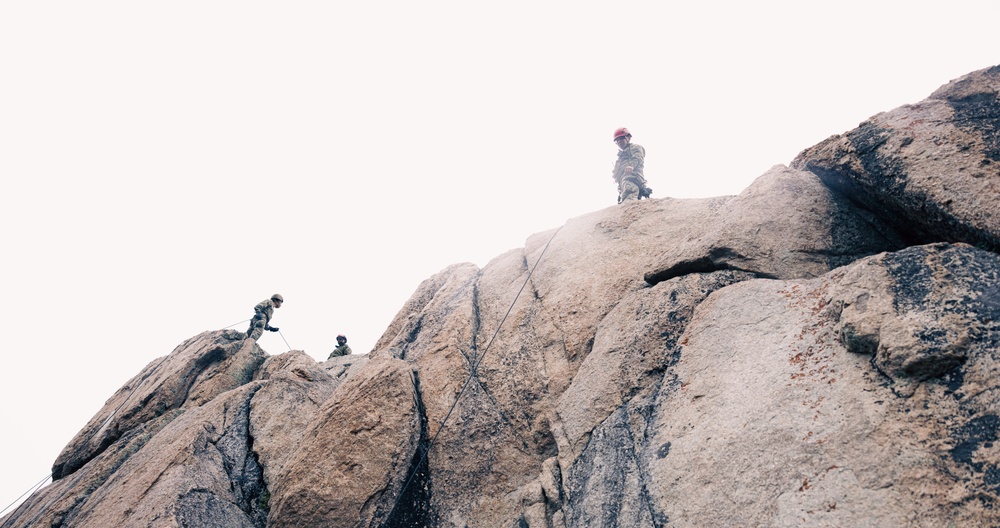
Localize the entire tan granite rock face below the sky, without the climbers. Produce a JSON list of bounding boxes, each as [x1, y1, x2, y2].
[[0, 64, 1000, 528]]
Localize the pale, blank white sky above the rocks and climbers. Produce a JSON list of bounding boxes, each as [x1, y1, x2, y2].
[[0, 0, 1000, 508]]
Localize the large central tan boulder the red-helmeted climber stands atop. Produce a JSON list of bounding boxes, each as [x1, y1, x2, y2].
[[354, 186, 916, 526]]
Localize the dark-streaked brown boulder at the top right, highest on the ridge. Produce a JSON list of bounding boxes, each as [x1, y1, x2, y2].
[[792, 66, 1000, 250]]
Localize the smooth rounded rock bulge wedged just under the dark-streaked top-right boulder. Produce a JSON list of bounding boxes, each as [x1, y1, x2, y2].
[[645, 165, 904, 284]]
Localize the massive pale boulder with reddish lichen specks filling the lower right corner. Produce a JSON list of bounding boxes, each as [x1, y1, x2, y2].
[[640, 245, 1000, 526]]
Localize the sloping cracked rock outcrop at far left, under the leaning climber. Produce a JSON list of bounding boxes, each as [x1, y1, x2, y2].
[[5, 331, 339, 527]]
